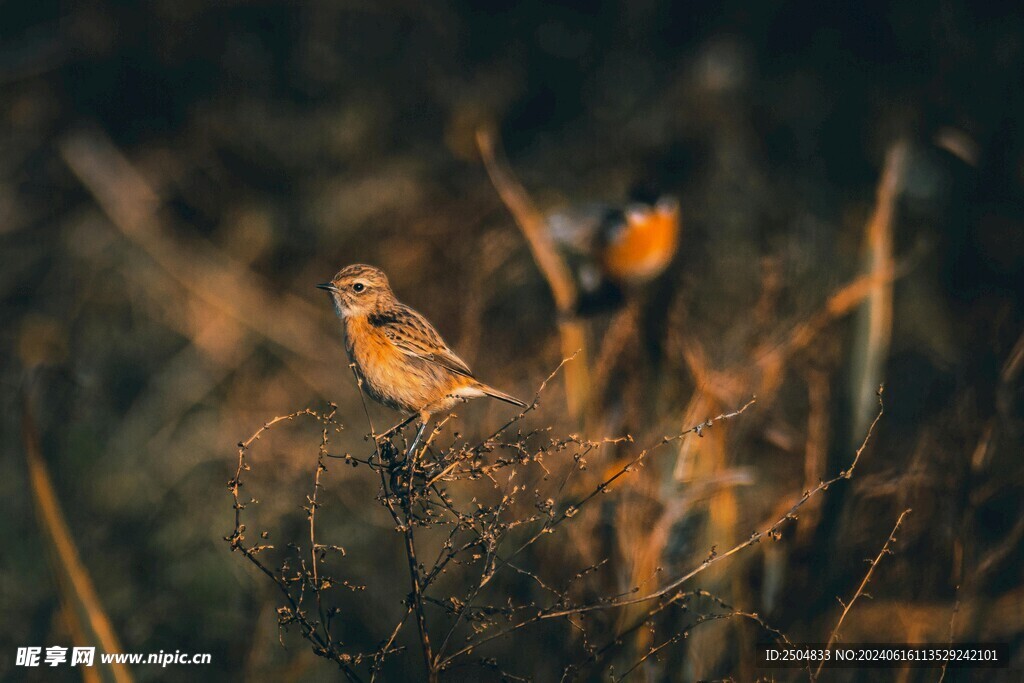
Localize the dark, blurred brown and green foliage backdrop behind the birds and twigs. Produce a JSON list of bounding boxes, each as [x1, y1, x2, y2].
[[0, 0, 1024, 680]]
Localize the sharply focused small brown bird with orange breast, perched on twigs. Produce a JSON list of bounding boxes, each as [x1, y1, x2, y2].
[[316, 264, 526, 440]]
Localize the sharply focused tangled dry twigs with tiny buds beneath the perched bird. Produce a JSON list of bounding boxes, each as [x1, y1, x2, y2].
[[225, 370, 881, 681]]
